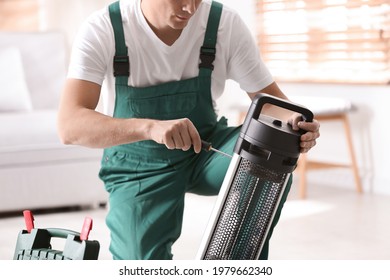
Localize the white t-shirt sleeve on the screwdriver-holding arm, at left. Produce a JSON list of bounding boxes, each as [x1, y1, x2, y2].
[[67, 10, 113, 85]]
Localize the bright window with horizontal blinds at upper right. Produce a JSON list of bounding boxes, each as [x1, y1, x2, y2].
[[257, 0, 390, 84]]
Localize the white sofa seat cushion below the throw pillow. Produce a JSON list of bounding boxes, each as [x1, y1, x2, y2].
[[0, 110, 102, 167]]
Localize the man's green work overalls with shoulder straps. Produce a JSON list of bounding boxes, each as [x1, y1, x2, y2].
[[99, 2, 288, 259]]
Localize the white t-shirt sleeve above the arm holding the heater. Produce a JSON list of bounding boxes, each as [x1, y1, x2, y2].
[[227, 14, 273, 92]]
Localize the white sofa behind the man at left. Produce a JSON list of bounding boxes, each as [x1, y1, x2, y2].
[[0, 32, 107, 212]]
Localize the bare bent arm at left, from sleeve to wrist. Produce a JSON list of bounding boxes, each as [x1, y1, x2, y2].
[[57, 79, 153, 148]]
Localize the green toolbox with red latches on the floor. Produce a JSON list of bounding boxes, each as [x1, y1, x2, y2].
[[14, 210, 100, 260]]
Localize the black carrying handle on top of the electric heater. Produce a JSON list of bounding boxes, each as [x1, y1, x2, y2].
[[242, 93, 314, 130]]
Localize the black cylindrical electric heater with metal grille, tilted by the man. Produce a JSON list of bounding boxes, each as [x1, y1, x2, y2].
[[197, 94, 313, 260]]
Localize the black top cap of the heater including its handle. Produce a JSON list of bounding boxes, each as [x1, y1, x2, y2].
[[234, 94, 313, 172]]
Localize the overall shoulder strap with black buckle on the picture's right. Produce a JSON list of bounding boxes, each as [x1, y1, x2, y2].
[[199, 1, 223, 75]]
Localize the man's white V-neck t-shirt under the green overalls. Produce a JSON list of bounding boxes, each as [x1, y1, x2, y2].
[[68, 0, 273, 116]]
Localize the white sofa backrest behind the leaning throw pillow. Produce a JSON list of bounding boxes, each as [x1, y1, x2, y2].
[[0, 31, 67, 110]]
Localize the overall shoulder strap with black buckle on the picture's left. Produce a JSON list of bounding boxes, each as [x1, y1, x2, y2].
[[108, 1, 130, 77]]
